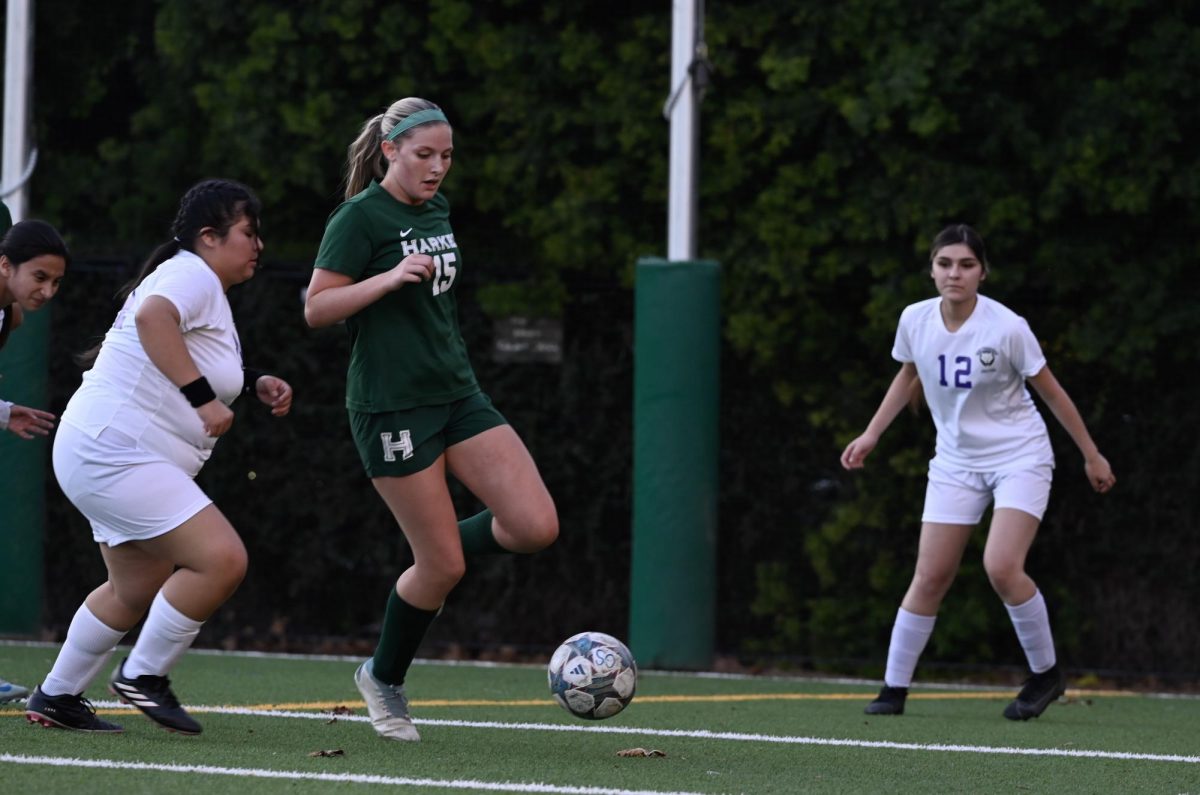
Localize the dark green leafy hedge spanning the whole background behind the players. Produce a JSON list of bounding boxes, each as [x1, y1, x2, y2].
[[23, 0, 1200, 671]]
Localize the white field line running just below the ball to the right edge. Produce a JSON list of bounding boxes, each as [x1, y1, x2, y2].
[[72, 701, 1200, 765]]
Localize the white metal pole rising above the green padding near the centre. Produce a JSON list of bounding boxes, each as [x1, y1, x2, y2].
[[666, 0, 703, 261]]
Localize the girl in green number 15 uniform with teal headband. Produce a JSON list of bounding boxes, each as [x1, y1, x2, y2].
[[305, 97, 558, 741]]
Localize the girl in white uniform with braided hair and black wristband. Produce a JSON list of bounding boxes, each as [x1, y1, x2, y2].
[[26, 180, 292, 734]]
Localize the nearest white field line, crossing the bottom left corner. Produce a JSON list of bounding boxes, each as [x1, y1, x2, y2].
[[0, 753, 701, 795]]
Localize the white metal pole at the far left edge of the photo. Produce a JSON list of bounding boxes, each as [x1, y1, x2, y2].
[[0, 0, 34, 223]]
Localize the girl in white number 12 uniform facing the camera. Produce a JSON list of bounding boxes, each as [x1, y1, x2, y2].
[[841, 225, 1116, 721]]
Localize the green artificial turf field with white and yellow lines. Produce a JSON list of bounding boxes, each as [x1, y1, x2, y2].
[[0, 644, 1200, 795]]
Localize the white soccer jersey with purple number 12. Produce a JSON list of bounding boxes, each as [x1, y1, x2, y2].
[[892, 295, 1054, 472]]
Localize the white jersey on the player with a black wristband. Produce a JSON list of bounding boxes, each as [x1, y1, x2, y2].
[[62, 251, 242, 477]]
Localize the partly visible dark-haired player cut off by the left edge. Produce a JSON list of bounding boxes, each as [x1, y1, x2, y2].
[[0, 213, 71, 704]]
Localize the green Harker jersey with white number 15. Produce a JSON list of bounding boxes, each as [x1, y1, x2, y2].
[[316, 181, 479, 413]]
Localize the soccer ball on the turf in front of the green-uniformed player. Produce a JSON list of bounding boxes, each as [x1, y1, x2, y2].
[[547, 632, 637, 721]]
